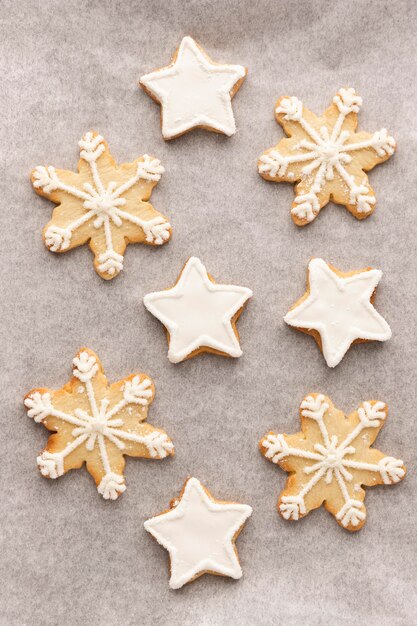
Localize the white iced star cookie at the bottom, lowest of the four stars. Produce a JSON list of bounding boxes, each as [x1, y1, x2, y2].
[[144, 478, 252, 589]]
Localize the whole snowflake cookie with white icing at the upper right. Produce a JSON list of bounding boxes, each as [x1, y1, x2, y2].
[[258, 88, 396, 226]]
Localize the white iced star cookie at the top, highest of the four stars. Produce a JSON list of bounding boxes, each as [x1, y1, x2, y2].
[[140, 37, 247, 139]]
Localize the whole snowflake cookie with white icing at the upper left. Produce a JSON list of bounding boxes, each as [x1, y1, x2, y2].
[[31, 132, 171, 280]]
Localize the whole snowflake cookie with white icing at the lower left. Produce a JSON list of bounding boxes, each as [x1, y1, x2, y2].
[[24, 348, 174, 500]]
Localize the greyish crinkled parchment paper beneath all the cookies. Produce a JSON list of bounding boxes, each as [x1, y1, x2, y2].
[[0, 0, 417, 626]]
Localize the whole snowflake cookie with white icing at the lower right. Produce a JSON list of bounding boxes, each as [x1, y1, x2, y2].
[[259, 393, 406, 530]]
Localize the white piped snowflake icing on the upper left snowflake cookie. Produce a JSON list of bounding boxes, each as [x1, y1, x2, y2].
[[33, 132, 170, 276]]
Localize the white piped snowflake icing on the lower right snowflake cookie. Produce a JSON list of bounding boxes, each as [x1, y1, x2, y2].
[[262, 394, 405, 527]]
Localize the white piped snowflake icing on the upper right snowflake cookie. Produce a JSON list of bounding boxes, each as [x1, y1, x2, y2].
[[259, 88, 395, 222]]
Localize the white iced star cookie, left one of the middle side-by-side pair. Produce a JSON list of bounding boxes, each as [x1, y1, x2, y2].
[[143, 257, 252, 363]]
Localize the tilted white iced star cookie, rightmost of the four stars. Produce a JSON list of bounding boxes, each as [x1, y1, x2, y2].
[[284, 259, 391, 367]]
